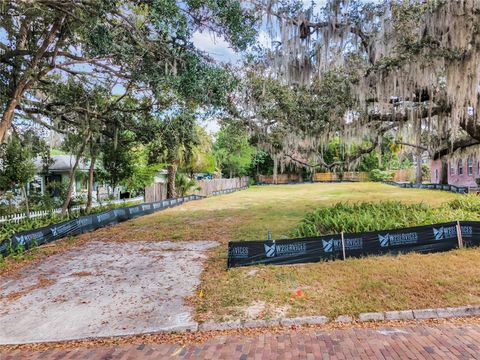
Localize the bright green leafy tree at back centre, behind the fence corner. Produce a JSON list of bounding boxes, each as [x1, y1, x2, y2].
[[214, 123, 255, 178]]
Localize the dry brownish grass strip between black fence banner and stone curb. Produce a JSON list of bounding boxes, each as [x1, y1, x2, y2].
[[192, 249, 480, 321]]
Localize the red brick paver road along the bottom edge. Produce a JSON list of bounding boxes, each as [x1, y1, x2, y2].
[[0, 324, 480, 360]]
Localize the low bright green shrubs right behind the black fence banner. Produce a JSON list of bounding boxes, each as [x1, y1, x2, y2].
[[293, 195, 480, 237]]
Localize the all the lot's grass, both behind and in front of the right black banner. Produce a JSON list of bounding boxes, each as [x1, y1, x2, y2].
[[5, 183, 480, 321]]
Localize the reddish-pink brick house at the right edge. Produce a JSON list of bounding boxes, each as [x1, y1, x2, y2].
[[430, 148, 480, 187]]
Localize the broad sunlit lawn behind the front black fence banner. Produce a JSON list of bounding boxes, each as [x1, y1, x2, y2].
[[84, 183, 459, 242]]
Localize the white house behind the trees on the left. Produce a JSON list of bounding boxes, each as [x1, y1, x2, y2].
[[28, 155, 97, 196]]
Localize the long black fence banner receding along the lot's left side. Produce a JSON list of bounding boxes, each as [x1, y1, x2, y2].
[[0, 186, 246, 255]]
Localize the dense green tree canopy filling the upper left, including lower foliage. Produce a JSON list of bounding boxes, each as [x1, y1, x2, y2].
[[0, 0, 256, 202]]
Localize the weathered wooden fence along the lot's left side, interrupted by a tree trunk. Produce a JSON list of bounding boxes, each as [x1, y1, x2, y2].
[[145, 177, 248, 203]]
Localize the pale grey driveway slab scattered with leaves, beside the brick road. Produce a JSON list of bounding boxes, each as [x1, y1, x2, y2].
[[0, 241, 217, 344]]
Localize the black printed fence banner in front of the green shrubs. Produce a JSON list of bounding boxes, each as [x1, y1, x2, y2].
[[228, 221, 480, 268]]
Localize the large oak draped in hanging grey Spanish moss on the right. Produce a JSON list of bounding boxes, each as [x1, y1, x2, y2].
[[249, 0, 480, 177]]
